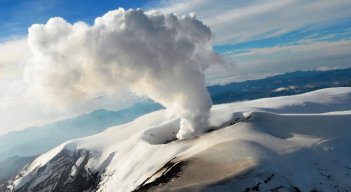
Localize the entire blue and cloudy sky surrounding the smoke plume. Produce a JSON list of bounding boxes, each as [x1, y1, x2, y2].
[[0, 0, 351, 135]]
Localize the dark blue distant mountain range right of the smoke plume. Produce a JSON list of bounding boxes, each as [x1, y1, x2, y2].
[[208, 68, 351, 104]]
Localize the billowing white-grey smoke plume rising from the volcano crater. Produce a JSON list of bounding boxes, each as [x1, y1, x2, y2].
[[26, 8, 221, 139]]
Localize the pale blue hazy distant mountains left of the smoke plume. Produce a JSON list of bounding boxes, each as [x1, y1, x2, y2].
[[0, 102, 160, 161]]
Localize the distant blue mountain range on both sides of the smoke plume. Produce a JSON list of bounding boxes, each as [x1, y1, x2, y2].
[[0, 68, 351, 183]]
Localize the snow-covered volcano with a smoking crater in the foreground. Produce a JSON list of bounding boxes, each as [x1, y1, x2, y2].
[[4, 87, 351, 192]]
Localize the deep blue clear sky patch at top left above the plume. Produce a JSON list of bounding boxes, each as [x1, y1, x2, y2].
[[0, 0, 157, 41]]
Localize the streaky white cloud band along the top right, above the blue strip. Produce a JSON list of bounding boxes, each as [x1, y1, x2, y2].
[[155, 0, 351, 44]]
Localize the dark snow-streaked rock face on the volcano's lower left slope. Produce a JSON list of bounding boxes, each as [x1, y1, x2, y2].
[[8, 149, 100, 192]]
